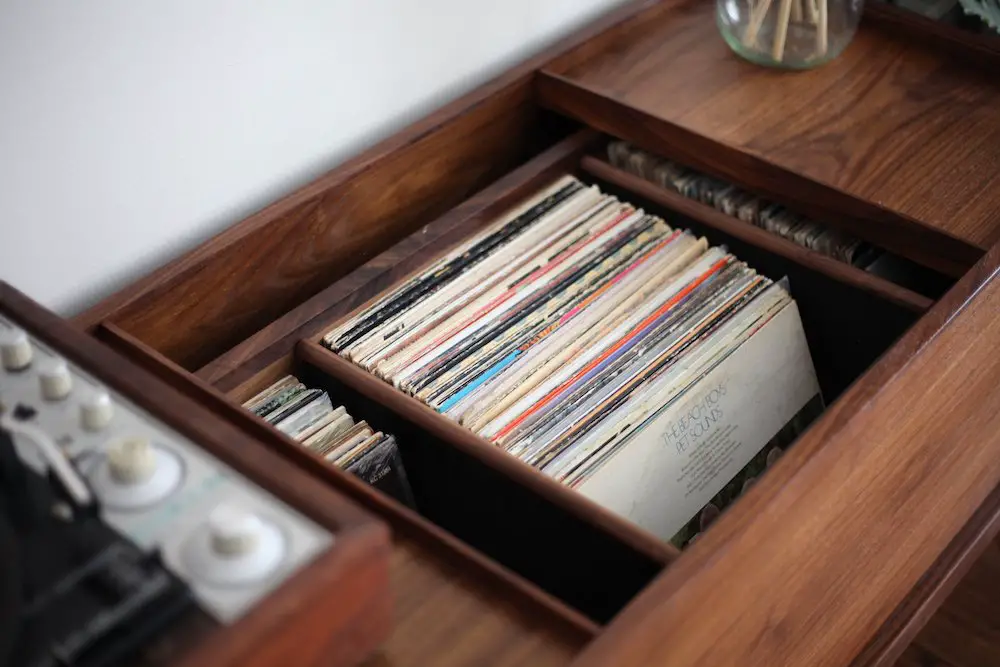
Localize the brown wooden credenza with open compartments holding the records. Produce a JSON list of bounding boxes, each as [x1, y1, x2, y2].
[[77, 0, 1000, 667]]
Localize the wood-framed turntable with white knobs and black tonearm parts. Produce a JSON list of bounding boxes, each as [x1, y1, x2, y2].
[[0, 283, 388, 667]]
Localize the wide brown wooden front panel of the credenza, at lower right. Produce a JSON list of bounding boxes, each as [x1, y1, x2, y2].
[[578, 241, 1000, 667]]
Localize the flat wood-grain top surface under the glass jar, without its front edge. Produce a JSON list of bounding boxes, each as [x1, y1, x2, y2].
[[549, 2, 1000, 249]]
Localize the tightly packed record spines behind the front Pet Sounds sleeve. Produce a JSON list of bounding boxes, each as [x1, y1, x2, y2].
[[324, 176, 811, 537]]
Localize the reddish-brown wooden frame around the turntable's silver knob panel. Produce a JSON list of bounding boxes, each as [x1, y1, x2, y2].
[[0, 282, 391, 667]]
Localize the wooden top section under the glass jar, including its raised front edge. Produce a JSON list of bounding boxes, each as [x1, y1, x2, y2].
[[538, 2, 1000, 276]]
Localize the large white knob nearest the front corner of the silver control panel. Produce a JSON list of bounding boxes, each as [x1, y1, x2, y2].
[[182, 504, 286, 587]]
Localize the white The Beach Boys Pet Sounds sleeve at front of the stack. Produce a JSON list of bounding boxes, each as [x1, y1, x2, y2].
[[577, 301, 820, 541]]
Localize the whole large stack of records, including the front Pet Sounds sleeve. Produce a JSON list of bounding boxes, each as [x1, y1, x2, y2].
[[324, 176, 821, 544]]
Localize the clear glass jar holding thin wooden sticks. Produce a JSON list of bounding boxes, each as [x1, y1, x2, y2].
[[715, 0, 864, 69]]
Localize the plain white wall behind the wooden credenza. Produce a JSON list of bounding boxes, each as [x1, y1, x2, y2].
[[0, 0, 620, 314]]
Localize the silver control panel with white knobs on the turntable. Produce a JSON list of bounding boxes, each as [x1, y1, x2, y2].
[[0, 315, 335, 623]]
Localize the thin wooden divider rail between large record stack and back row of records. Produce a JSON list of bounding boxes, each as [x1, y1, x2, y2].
[[582, 156, 933, 313]]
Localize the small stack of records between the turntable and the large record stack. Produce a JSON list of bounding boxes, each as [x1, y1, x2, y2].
[[243, 375, 414, 507]]
